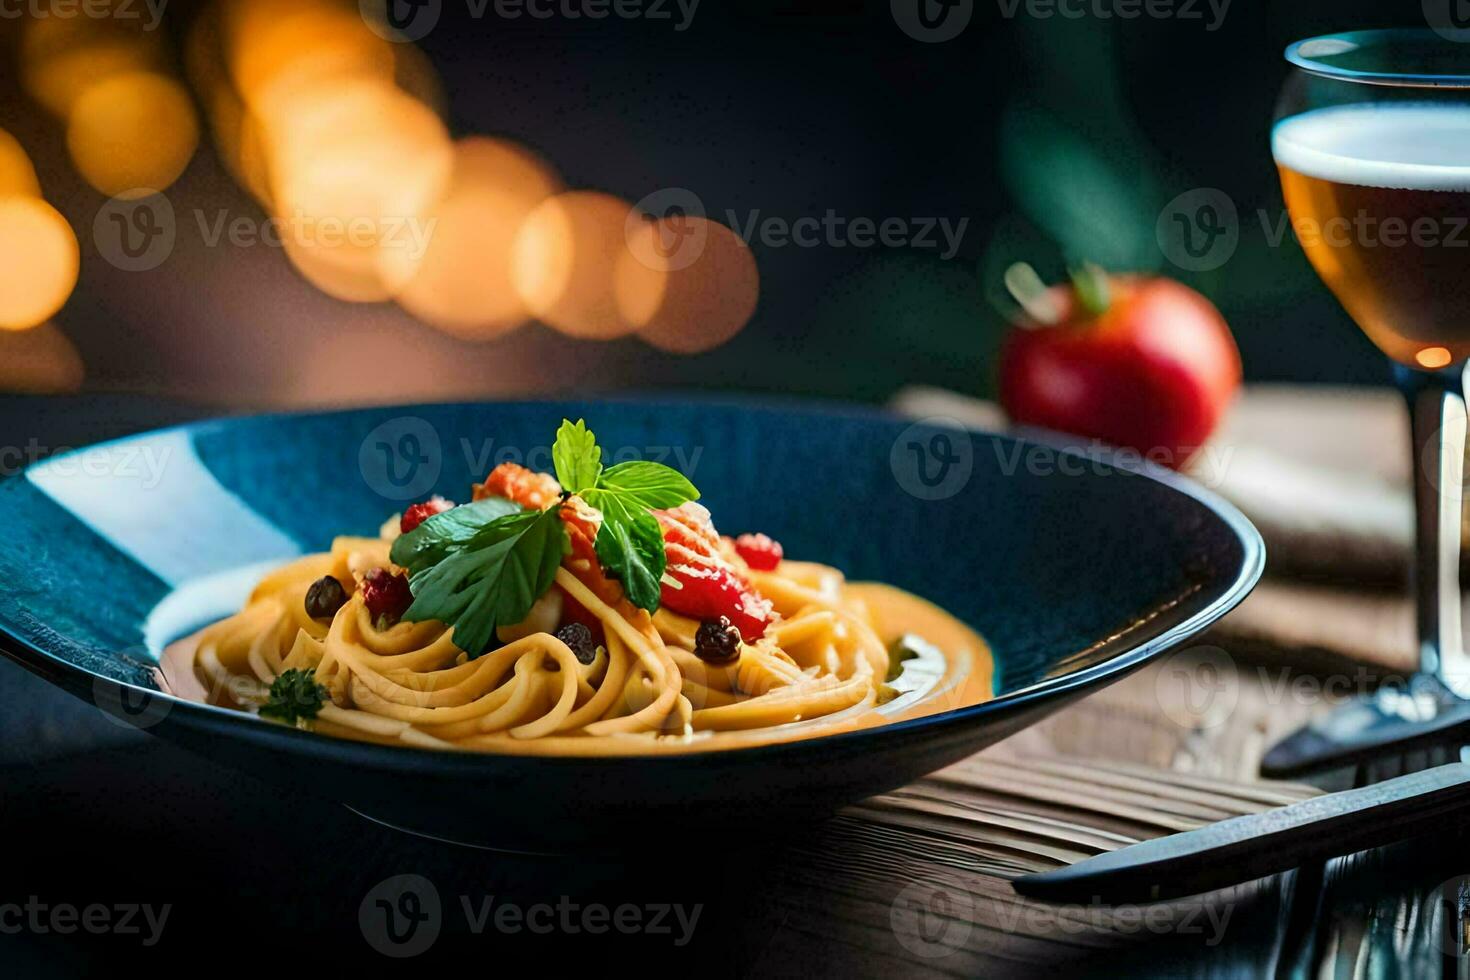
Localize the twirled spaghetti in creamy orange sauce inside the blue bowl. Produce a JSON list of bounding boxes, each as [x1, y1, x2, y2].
[[165, 423, 989, 755]]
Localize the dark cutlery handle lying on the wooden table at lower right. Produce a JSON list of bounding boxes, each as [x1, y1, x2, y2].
[[1014, 763, 1470, 905]]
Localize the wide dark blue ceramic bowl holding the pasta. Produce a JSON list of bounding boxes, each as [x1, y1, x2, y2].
[[0, 400, 1264, 851]]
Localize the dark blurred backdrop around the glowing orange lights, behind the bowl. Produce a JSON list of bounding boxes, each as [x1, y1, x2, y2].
[[0, 0, 1424, 408]]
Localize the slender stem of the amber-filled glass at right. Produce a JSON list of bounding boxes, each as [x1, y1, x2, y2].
[[1395, 366, 1470, 698]]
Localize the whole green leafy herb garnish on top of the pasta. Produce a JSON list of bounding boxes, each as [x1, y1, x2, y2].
[[390, 420, 700, 657]]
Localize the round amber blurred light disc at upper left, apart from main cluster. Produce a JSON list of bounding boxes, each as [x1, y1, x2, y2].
[[66, 72, 198, 197]]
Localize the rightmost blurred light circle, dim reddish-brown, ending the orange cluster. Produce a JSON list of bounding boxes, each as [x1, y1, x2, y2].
[[617, 216, 760, 354]]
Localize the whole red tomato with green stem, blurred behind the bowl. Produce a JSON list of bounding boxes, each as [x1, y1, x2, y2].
[[1001, 268, 1241, 467]]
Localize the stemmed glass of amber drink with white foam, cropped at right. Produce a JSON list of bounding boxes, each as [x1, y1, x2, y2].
[[1261, 29, 1470, 774]]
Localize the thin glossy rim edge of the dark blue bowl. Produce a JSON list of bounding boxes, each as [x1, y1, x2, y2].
[[0, 392, 1266, 774]]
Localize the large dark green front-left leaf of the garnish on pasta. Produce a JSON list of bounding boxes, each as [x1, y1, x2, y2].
[[403, 507, 570, 657]]
